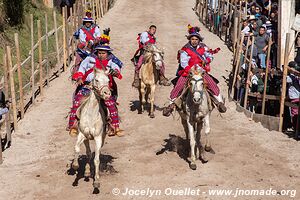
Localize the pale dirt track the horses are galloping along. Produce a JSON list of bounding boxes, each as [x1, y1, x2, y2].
[[0, 0, 300, 200]]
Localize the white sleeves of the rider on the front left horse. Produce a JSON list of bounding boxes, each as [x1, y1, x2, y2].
[[78, 56, 121, 82]]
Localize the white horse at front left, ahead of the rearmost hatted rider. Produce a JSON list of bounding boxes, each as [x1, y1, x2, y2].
[[72, 68, 111, 188]]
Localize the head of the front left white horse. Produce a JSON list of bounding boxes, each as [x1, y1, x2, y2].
[[92, 68, 111, 100]]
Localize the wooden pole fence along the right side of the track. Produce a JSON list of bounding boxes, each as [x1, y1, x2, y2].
[[194, 0, 300, 134]]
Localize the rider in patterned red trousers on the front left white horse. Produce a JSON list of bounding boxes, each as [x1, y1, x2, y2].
[[67, 45, 123, 136]]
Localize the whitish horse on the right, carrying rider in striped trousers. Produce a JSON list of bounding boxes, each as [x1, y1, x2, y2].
[[181, 68, 212, 170]]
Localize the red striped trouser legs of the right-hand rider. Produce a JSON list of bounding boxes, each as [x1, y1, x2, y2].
[[170, 73, 220, 100]]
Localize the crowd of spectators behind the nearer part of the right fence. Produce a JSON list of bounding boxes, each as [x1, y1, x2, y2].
[[235, 0, 300, 133]]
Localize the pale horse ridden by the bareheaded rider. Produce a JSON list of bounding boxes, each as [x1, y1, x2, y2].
[[139, 44, 164, 118]]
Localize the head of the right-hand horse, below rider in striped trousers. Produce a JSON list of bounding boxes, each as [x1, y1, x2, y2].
[[189, 67, 205, 104]]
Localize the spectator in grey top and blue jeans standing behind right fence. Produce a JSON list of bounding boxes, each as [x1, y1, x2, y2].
[[255, 26, 269, 69]]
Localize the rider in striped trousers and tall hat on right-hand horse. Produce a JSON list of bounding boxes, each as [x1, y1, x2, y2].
[[163, 25, 226, 116]]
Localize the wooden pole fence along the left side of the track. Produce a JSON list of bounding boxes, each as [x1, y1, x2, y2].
[[0, 0, 109, 164]]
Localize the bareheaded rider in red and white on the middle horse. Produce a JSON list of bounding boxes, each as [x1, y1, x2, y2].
[[131, 25, 171, 88]]
